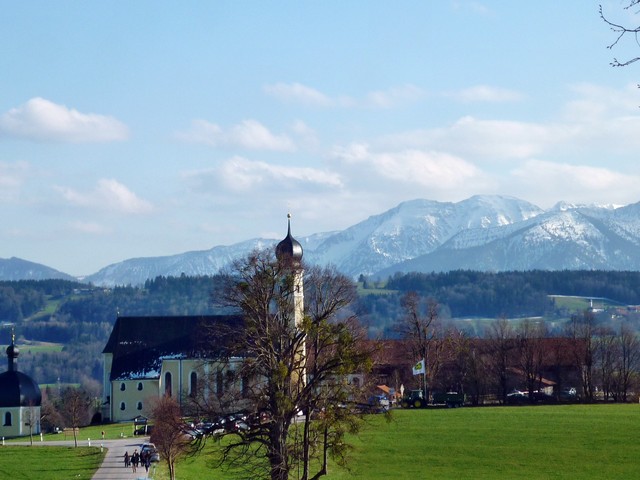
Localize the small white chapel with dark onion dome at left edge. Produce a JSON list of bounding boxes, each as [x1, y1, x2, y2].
[[0, 333, 42, 438]]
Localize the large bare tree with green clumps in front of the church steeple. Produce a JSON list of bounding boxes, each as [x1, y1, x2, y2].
[[202, 251, 370, 480]]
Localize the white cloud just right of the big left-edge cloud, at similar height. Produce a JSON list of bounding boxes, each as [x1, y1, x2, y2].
[[177, 120, 295, 152]]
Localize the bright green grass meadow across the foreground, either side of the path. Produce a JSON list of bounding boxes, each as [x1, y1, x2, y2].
[[0, 404, 640, 480]]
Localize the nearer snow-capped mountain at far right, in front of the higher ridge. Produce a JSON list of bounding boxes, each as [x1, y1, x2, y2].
[[378, 204, 640, 276]]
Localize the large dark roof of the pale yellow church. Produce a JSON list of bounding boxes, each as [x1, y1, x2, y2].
[[103, 315, 243, 380]]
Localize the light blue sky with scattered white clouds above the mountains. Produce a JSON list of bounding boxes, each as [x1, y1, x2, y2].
[[0, 0, 640, 276]]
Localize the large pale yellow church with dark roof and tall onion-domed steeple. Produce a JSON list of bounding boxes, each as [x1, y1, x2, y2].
[[102, 216, 304, 422]]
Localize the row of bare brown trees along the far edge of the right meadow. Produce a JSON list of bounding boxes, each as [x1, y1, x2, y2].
[[398, 292, 640, 405]]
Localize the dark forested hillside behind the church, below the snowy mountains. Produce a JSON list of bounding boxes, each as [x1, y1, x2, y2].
[[0, 271, 640, 383]]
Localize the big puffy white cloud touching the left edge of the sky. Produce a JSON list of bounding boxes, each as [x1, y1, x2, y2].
[[0, 97, 129, 143]]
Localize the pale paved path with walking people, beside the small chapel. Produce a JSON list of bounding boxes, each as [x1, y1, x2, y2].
[[12, 437, 155, 480]]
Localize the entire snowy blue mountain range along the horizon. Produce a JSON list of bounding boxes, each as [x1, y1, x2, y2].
[[0, 195, 640, 286]]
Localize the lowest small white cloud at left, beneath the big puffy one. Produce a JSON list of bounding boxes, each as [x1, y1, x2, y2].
[[56, 178, 153, 214]]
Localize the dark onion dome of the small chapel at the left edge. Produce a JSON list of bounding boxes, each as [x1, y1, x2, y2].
[[0, 339, 42, 408]]
